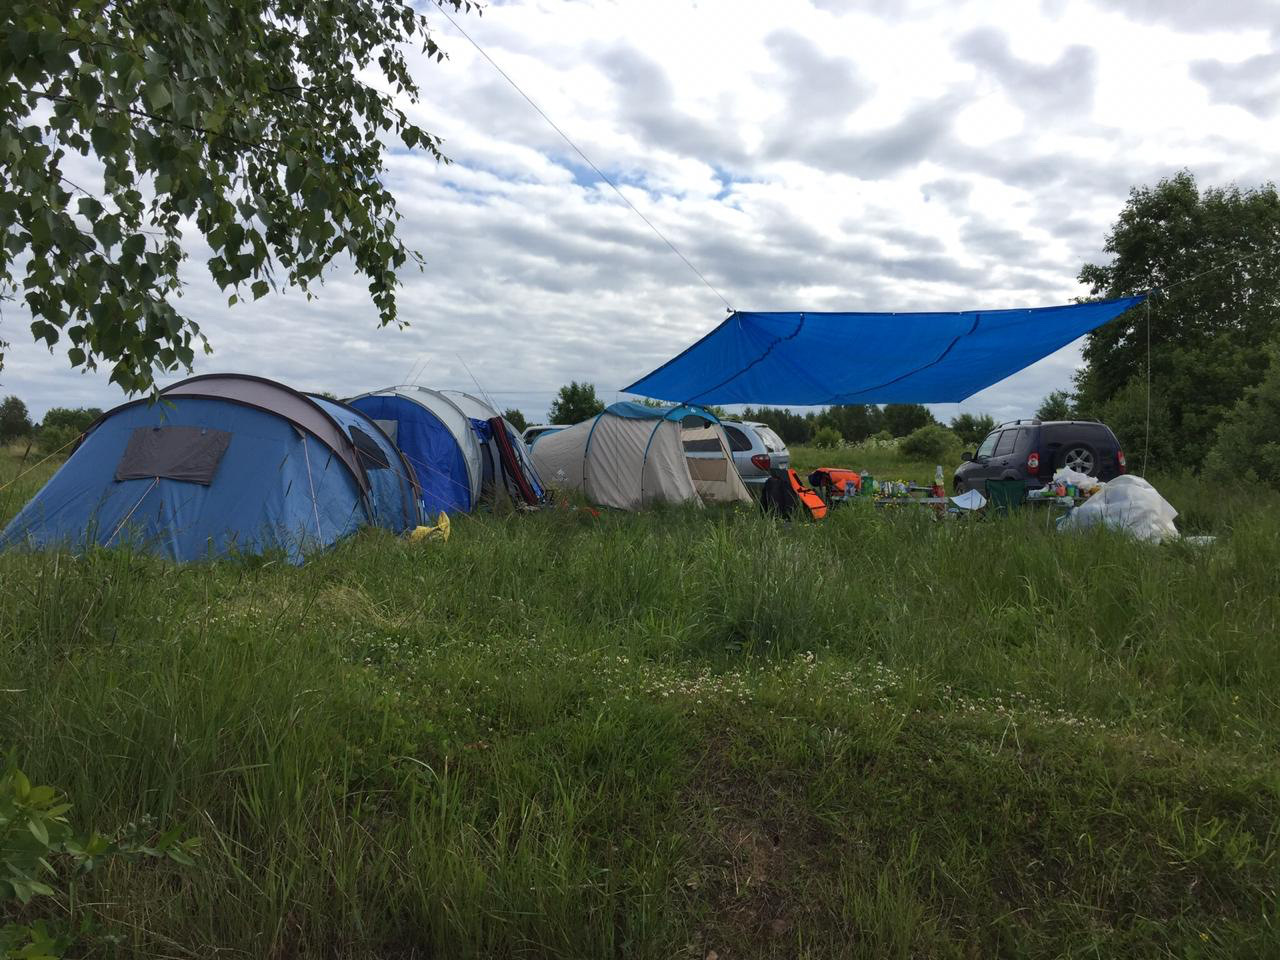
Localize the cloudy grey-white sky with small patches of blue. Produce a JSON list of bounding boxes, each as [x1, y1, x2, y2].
[[0, 0, 1280, 421]]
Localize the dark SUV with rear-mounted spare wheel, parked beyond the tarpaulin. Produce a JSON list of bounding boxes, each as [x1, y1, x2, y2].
[[952, 420, 1125, 493]]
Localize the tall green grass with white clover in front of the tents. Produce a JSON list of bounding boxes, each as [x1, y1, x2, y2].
[[0, 449, 1280, 960]]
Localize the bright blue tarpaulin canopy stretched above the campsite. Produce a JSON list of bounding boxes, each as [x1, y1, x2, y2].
[[623, 296, 1143, 406]]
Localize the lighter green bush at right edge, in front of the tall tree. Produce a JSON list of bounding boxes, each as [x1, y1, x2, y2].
[[1204, 339, 1280, 489]]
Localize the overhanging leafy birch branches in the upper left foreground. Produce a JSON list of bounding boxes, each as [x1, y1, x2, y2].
[[0, 0, 471, 390]]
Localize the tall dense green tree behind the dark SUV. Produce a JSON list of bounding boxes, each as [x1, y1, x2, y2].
[[1076, 172, 1280, 476]]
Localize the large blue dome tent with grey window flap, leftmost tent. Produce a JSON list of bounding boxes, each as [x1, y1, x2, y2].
[[0, 374, 420, 563]]
